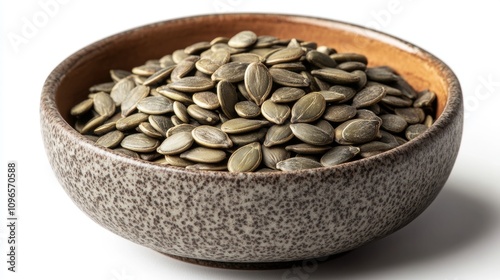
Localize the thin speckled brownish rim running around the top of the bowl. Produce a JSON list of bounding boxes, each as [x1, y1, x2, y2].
[[40, 12, 463, 179]]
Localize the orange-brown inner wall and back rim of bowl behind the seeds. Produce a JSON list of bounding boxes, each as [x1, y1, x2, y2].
[[55, 14, 449, 124]]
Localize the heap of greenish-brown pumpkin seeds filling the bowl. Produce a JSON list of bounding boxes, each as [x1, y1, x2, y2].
[[71, 31, 436, 172]]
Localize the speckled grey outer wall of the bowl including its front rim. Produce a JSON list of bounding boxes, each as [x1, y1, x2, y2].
[[40, 13, 463, 262]]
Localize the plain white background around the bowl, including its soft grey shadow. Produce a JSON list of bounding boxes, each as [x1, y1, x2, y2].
[[0, 0, 500, 280]]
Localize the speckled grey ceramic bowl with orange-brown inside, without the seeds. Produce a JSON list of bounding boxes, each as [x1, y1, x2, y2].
[[40, 14, 463, 268]]
